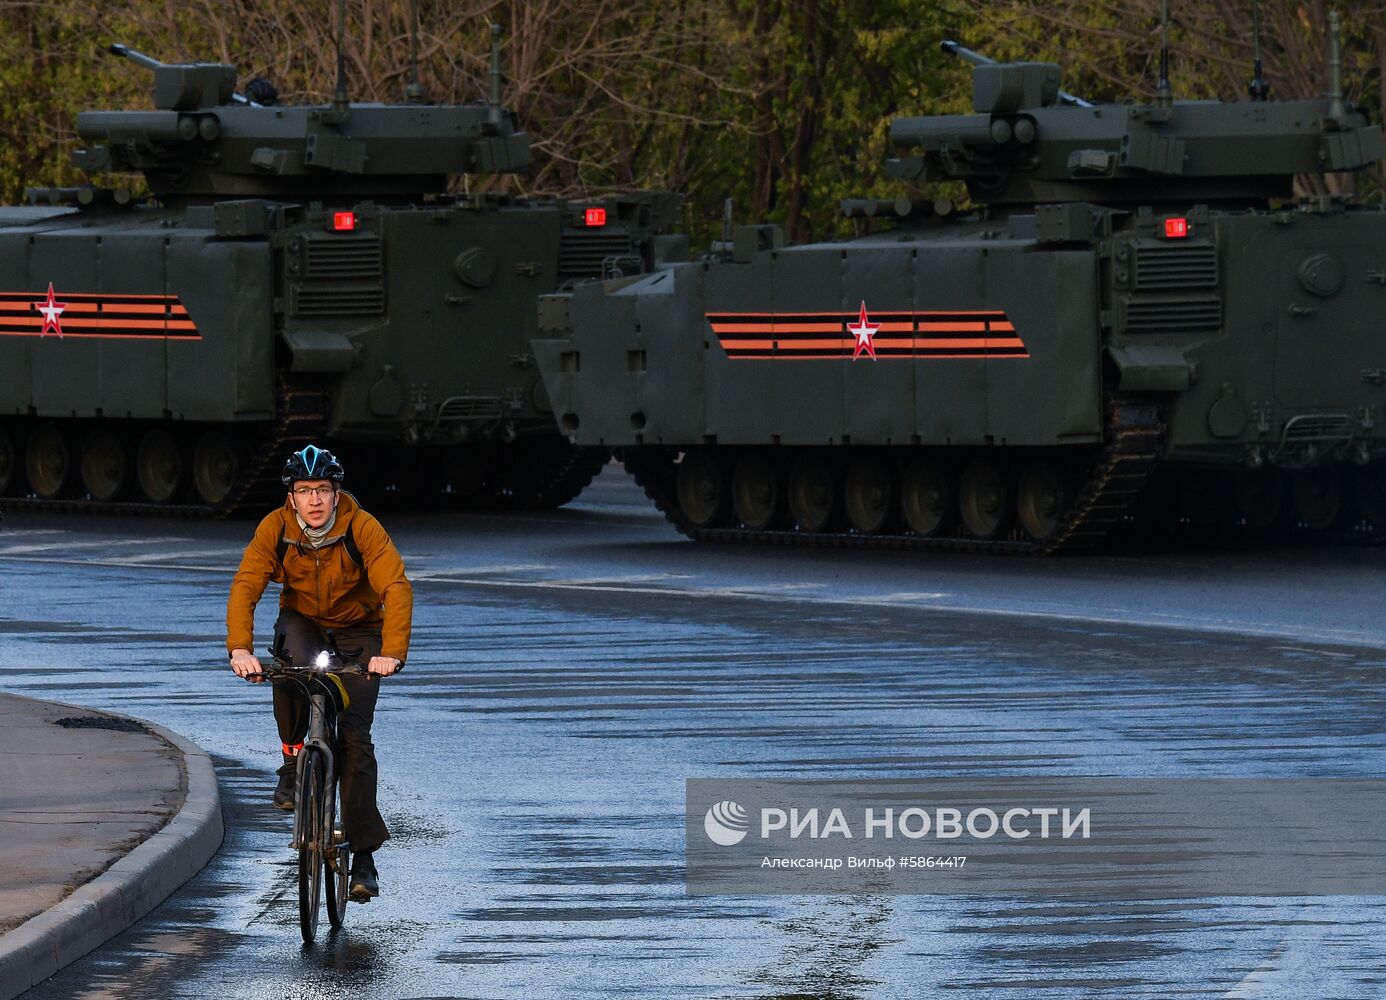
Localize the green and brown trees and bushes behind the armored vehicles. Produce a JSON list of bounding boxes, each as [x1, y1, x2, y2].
[[8, 0, 1386, 228]]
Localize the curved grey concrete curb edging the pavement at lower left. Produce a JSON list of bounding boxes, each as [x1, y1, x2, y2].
[[0, 706, 223, 1000]]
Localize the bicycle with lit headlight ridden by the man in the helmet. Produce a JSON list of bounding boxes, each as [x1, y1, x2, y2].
[[247, 633, 366, 945]]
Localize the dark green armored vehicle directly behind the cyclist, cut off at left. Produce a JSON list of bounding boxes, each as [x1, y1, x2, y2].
[[0, 31, 678, 514]]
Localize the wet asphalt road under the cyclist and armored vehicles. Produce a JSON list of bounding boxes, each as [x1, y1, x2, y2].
[[0, 462, 1386, 999]]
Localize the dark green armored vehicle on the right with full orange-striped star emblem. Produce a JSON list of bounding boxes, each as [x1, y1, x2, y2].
[[536, 19, 1386, 553]]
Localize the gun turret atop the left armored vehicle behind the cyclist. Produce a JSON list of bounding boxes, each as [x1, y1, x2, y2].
[[73, 33, 531, 199]]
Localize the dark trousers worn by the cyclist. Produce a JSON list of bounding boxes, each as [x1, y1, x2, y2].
[[274, 609, 389, 852]]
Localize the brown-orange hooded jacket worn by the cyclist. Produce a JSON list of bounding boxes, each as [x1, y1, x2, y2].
[[226, 492, 414, 662]]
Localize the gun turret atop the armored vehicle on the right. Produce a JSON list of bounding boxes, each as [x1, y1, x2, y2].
[[886, 42, 1383, 205]]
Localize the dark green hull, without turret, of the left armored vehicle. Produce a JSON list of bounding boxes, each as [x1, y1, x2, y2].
[[0, 188, 670, 512]]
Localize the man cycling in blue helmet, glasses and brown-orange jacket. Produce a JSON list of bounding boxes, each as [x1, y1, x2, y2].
[[226, 445, 414, 903]]
